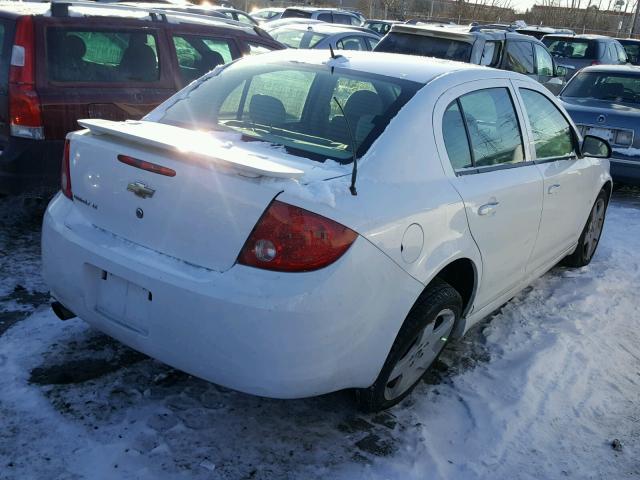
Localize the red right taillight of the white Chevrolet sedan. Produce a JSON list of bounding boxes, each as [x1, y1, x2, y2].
[[238, 200, 358, 272]]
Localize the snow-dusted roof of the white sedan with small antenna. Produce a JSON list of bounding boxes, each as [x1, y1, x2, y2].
[[242, 49, 520, 84]]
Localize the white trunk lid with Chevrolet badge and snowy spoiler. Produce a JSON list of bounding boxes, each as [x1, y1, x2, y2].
[[69, 120, 344, 272]]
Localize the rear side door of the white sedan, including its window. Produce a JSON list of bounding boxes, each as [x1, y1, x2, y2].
[[433, 80, 542, 308]]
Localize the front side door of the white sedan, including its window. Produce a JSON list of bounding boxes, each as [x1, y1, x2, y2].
[[514, 81, 593, 269]]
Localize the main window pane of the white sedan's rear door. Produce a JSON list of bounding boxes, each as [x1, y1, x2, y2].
[[459, 88, 524, 167]]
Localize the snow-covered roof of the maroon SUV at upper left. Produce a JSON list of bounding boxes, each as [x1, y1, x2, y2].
[[0, 2, 257, 31]]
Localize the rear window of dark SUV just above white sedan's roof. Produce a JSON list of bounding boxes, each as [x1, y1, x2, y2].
[[375, 32, 472, 62]]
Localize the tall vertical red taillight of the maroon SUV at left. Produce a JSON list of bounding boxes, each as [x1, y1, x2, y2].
[[9, 16, 44, 140]]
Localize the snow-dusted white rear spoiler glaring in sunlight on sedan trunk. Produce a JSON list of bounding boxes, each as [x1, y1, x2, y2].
[[78, 119, 304, 178]]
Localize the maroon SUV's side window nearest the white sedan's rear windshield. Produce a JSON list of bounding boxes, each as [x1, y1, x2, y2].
[[173, 35, 232, 83]]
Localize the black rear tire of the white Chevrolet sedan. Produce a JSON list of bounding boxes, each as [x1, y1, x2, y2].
[[356, 278, 462, 412]]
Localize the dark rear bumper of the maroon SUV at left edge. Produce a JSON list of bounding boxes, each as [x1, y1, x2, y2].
[[0, 137, 64, 195]]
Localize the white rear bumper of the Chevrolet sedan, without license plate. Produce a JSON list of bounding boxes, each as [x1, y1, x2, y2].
[[42, 194, 423, 398]]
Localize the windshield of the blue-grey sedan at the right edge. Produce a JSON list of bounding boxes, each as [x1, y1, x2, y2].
[[562, 72, 640, 103]]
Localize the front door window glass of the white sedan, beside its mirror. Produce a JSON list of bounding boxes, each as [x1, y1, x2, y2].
[[520, 89, 574, 160]]
